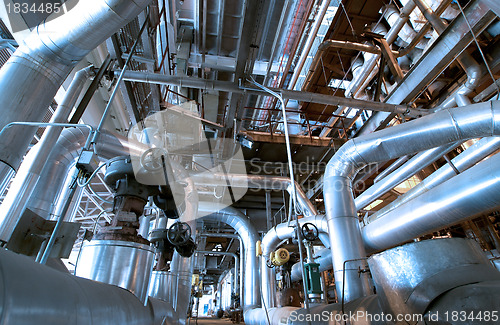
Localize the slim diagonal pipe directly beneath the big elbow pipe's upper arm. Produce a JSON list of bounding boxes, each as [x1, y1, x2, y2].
[[354, 142, 460, 210]]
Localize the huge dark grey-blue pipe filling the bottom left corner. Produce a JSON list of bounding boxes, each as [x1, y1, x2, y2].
[[0, 249, 172, 325]]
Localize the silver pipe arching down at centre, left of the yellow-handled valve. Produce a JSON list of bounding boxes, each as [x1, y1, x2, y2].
[[199, 202, 260, 311]]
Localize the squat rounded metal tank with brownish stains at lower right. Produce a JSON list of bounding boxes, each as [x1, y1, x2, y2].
[[368, 238, 500, 315]]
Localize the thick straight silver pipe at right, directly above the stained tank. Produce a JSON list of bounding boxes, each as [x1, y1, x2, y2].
[[362, 155, 500, 252]]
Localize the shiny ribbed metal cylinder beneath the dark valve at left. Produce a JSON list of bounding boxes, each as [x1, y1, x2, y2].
[[75, 240, 154, 302]]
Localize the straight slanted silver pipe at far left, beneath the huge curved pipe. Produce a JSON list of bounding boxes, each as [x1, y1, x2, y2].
[[0, 67, 92, 238]]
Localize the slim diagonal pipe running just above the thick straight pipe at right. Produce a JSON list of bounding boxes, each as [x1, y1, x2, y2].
[[367, 137, 500, 223]]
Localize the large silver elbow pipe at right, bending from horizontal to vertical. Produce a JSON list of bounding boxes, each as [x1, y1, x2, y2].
[[323, 101, 500, 302]]
